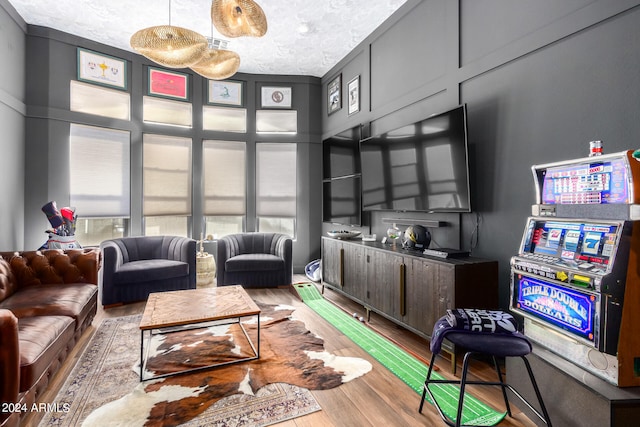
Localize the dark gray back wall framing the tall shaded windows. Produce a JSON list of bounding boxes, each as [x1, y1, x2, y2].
[[21, 25, 321, 271]]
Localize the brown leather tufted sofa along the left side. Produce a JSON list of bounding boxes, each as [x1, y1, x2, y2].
[[0, 249, 100, 427]]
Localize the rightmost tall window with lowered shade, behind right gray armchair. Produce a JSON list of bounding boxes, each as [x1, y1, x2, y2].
[[256, 143, 297, 237]]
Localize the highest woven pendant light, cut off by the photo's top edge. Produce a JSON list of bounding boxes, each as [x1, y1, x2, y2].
[[211, 0, 267, 37]]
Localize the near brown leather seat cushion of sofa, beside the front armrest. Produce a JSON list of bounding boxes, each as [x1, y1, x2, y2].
[[18, 316, 74, 392]]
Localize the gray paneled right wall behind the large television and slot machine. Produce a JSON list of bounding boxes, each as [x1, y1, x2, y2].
[[322, 0, 640, 307]]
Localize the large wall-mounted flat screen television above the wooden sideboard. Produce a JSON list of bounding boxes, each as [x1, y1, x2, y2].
[[360, 105, 471, 212]]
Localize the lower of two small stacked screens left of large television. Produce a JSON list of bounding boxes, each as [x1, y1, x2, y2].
[[322, 175, 362, 225]]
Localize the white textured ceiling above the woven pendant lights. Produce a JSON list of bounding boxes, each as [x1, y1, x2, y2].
[[9, 0, 406, 77]]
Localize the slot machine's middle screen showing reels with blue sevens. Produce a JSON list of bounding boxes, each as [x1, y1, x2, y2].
[[522, 218, 620, 270]]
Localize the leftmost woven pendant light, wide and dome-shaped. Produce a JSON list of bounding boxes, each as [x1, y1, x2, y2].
[[130, 25, 207, 68]]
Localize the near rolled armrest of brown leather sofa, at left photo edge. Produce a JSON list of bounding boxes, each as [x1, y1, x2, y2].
[[0, 309, 20, 425]]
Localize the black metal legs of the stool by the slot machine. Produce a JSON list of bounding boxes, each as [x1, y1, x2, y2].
[[418, 351, 551, 427]]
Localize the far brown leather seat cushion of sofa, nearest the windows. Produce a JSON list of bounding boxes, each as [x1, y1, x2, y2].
[[0, 283, 98, 328]]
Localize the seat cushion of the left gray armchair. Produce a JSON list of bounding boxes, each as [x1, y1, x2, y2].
[[113, 259, 189, 285]]
